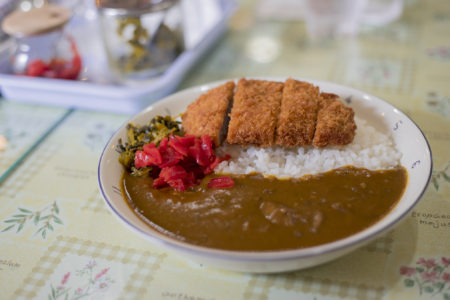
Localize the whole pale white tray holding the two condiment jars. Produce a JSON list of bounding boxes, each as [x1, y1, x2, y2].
[[0, 0, 237, 114]]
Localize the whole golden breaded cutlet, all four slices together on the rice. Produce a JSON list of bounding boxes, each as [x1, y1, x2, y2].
[[182, 78, 356, 148]]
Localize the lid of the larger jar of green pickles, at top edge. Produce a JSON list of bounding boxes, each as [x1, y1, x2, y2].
[[95, 0, 179, 16]]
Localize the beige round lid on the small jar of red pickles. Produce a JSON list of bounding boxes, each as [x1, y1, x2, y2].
[[2, 4, 71, 37]]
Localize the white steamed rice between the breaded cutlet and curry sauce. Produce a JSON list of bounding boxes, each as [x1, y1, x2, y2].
[[216, 117, 401, 178]]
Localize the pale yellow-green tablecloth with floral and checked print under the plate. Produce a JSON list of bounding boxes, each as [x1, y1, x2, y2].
[[0, 0, 450, 300]]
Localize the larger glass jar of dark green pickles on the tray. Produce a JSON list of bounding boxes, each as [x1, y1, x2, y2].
[[96, 0, 184, 84]]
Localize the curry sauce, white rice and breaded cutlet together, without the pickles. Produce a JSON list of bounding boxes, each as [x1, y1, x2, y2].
[[122, 79, 407, 251]]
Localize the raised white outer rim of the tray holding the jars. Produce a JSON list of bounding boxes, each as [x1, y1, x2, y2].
[[0, 0, 236, 114]]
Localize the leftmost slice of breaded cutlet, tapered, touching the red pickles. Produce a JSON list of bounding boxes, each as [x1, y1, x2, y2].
[[182, 81, 235, 146]]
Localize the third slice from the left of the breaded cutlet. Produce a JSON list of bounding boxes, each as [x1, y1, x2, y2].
[[276, 78, 319, 147]]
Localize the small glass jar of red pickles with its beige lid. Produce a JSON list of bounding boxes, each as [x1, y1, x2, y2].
[[2, 5, 81, 79]]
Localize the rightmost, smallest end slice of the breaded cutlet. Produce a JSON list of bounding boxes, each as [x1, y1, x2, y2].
[[312, 93, 356, 148]]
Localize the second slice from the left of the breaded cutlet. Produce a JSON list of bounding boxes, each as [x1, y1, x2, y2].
[[227, 78, 284, 147]]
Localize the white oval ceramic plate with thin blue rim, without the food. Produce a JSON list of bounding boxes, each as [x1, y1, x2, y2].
[[98, 78, 432, 272]]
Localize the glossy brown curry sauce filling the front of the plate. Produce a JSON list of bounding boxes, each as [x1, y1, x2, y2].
[[121, 167, 407, 251]]
